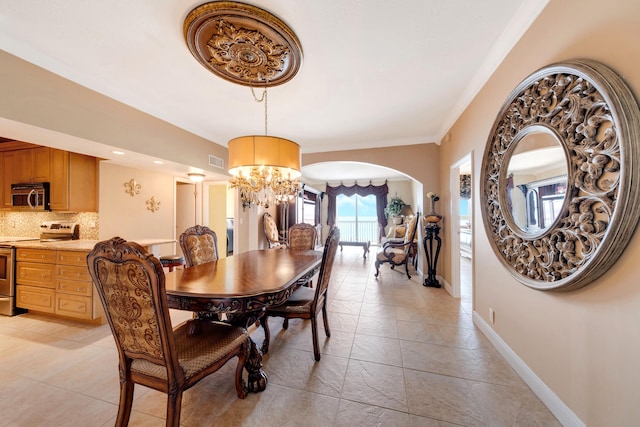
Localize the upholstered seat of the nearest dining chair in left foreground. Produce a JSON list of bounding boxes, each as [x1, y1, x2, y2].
[[131, 322, 248, 380]]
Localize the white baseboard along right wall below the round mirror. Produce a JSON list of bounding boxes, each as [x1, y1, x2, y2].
[[473, 311, 586, 427]]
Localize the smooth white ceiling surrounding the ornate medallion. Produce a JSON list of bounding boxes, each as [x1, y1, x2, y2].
[[0, 0, 548, 180]]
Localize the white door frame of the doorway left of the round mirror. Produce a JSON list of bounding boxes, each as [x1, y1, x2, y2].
[[449, 151, 475, 298]]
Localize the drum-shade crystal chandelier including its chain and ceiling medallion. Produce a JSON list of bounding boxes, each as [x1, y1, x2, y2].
[[184, 1, 302, 208]]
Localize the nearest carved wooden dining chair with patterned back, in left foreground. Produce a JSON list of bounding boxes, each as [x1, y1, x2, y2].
[[87, 237, 249, 426]]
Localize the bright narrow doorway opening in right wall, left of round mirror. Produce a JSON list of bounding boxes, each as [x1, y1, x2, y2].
[[450, 153, 474, 313]]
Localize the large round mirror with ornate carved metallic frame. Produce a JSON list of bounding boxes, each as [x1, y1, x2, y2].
[[480, 60, 640, 291]]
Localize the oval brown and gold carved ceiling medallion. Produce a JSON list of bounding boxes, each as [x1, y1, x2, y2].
[[184, 1, 302, 86]]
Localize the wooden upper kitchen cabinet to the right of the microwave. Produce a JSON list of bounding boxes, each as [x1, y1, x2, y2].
[[49, 149, 98, 212]]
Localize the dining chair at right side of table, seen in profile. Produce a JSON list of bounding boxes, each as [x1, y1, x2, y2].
[[260, 227, 340, 360]]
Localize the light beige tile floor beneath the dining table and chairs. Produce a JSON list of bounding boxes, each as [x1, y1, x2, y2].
[[0, 247, 560, 427]]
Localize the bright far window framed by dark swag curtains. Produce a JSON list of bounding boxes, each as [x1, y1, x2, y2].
[[336, 194, 379, 242]]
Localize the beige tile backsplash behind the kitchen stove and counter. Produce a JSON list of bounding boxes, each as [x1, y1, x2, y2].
[[0, 212, 100, 240]]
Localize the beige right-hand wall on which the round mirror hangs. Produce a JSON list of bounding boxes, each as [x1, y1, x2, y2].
[[440, 0, 640, 426]]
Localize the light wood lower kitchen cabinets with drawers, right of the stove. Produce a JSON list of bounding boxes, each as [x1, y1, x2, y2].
[[16, 248, 104, 322]]
